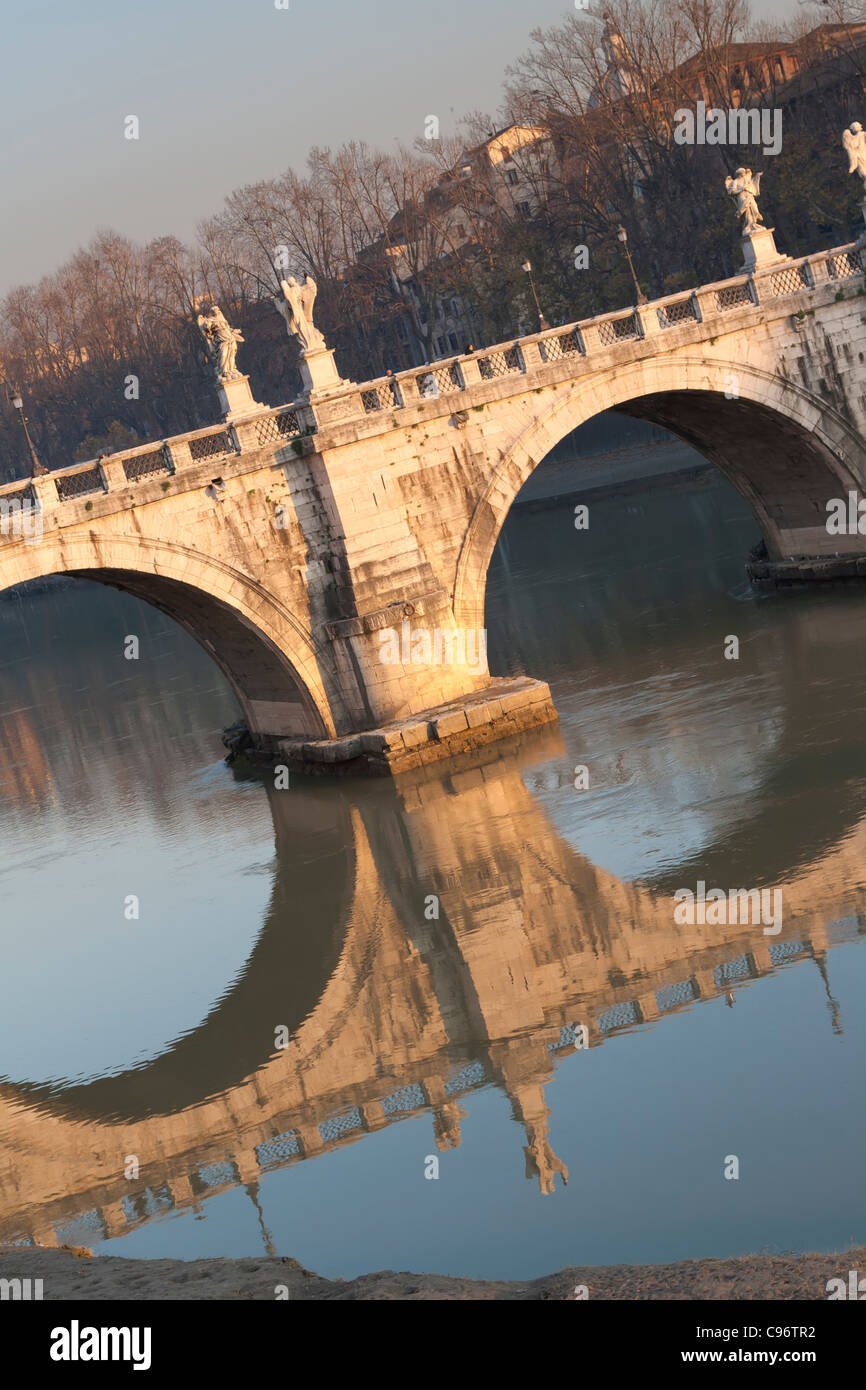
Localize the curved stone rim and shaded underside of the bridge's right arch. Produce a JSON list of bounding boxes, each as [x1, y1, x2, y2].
[[453, 357, 866, 630]]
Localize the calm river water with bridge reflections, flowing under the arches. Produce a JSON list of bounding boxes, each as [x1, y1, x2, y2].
[[0, 478, 866, 1277]]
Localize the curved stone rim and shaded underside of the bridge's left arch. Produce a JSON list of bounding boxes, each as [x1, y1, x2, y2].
[[0, 532, 335, 737]]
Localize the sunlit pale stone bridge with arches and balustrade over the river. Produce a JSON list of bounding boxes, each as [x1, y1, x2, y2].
[[0, 232, 866, 771]]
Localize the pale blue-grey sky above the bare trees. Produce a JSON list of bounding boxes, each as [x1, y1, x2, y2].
[[0, 0, 795, 293]]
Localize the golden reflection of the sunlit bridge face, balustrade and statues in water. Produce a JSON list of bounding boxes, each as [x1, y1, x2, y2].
[[0, 735, 866, 1244]]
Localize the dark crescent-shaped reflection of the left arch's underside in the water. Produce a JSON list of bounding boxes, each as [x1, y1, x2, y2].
[[0, 787, 356, 1123]]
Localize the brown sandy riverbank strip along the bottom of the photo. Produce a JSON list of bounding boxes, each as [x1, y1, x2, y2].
[[0, 1247, 866, 1302]]
